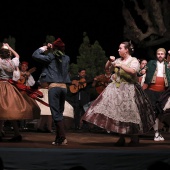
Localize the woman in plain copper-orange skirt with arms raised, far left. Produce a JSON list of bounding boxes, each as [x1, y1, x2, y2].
[[0, 43, 40, 142]]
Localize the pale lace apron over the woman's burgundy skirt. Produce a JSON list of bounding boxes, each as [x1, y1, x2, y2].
[[88, 83, 141, 124]]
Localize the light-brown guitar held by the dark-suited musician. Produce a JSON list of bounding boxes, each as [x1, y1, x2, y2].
[[69, 78, 87, 93]]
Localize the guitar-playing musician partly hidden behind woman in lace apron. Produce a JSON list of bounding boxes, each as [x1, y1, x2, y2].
[[92, 69, 112, 94]]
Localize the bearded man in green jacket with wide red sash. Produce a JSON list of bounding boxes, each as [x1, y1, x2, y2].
[[142, 48, 170, 141]]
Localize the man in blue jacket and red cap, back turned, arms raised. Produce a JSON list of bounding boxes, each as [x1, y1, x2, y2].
[[32, 38, 71, 145]]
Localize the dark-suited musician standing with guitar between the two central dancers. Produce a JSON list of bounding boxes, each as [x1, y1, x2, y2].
[[71, 68, 91, 130]]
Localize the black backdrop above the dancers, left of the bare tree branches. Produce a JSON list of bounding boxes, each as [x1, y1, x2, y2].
[[0, 0, 124, 65]]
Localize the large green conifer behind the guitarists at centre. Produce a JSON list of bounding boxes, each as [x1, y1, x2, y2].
[[70, 33, 107, 78]]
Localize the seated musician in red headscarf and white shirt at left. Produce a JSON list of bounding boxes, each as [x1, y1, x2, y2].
[[18, 61, 35, 86]]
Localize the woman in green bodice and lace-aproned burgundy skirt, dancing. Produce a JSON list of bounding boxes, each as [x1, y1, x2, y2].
[[82, 42, 154, 146]]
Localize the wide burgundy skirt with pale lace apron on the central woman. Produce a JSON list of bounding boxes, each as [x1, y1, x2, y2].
[[82, 83, 155, 134]]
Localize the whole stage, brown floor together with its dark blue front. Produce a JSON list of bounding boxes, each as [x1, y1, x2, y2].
[[0, 130, 170, 170]]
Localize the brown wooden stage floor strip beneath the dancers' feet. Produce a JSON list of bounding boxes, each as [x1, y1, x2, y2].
[[0, 130, 170, 150]]
